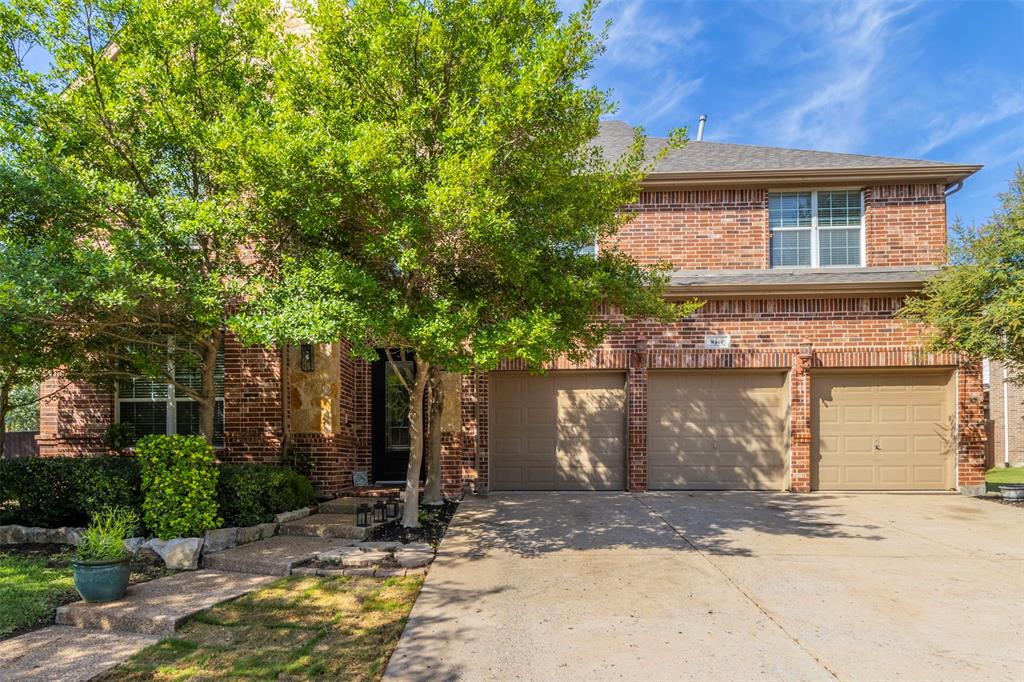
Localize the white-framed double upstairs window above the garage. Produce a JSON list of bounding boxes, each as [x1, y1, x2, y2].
[[768, 189, 864, 267]]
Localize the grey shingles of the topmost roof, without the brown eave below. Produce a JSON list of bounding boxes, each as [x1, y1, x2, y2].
[[594, 121, 980, 176]]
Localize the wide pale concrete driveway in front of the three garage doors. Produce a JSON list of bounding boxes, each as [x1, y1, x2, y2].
[[386, 493, 1024, 681]]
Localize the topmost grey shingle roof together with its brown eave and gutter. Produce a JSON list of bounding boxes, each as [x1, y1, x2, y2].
[[594, 121, 981, 184]]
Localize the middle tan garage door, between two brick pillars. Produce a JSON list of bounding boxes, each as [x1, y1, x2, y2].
[[647, 370, 788, 491]]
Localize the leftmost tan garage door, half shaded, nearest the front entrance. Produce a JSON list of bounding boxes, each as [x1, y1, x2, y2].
[[489, 372, 626, 491]]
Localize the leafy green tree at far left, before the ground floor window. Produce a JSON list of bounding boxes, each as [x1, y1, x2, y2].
[[0, 0, 288, 439]]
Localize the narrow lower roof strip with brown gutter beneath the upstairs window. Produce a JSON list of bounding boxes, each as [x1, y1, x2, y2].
[[668, 265, 941, 297]]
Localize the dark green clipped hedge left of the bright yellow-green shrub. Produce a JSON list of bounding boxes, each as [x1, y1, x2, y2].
[[0, 457, 142, 527]]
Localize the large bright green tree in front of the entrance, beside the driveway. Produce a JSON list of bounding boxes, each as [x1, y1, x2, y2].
[[236, 0, 694, 526]]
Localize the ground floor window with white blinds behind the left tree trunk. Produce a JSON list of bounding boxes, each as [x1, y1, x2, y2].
[[116, 348, 224, 445]]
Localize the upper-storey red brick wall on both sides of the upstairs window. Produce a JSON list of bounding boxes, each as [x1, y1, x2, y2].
[[605, 184, 946, 270]]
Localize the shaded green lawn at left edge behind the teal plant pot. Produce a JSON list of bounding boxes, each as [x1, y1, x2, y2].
[[0, 545, 174, 639]]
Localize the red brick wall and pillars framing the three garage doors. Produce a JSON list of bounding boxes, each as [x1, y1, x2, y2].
[[462, 297, 985, 492]]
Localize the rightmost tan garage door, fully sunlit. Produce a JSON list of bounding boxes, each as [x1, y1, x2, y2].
[[811, 370, 953, 491]]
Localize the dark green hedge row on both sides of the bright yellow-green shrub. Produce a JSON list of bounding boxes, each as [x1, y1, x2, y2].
[[0, 456, 313, 535]]
